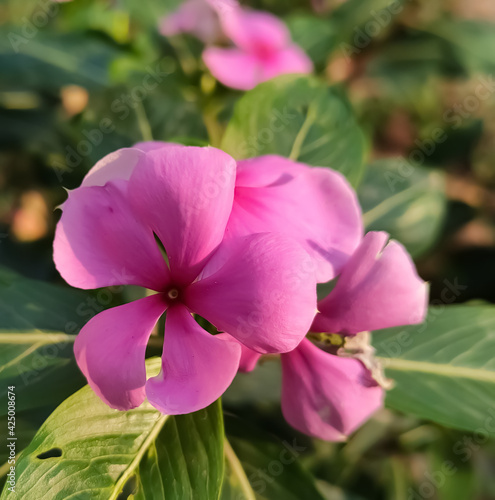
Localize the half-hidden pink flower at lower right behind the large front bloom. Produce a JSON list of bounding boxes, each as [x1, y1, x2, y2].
[[240, 232, 428, 441]]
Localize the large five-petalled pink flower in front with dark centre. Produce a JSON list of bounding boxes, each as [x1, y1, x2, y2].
[[54, 143, 316, 414]]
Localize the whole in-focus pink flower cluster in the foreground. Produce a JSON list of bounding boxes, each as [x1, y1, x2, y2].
[[54, 142, 427, 440]]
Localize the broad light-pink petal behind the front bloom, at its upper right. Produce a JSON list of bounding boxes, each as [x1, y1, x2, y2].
[[230, 156, 363, 282]]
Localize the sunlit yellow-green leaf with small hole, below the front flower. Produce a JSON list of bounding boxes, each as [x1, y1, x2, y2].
[[0, 359, 224, 500]]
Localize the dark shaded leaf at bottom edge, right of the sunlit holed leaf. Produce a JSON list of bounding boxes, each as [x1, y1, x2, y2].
[[221, 415, 323, 500]]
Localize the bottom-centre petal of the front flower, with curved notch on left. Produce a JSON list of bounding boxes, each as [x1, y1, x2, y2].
[[146, 305, 241, 415]]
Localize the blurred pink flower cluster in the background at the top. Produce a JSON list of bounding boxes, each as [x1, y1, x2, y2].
[[160, 0, 313, 90]]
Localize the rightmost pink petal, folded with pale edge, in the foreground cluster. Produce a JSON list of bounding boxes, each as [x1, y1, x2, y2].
[[311, 232, 428, 334]]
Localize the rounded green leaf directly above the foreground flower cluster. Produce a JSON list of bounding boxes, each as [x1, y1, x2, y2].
[[222, 75, 365, 185]]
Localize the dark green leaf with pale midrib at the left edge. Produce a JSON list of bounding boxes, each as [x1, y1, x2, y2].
[[0, 268, 91, 416]]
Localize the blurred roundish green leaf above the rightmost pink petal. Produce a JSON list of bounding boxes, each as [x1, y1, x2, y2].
[[358, 159, 446, 257]]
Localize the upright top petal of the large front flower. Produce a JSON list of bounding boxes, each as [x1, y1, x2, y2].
[[129, 145, 236, 284]]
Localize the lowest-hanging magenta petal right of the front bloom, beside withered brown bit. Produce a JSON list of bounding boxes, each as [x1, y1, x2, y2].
[[281, 339, 384, 441]]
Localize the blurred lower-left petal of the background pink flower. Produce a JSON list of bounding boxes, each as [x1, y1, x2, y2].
[[203, 47, 263, 90]]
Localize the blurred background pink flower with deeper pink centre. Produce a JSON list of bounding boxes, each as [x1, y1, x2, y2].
[[203, 9, 313, 90]]
